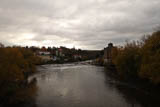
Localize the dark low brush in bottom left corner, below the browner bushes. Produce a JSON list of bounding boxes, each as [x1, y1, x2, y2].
[[0, 78, 38, 107]]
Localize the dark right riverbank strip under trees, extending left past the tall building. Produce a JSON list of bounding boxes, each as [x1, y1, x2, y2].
[[91, 59, 160, 96]]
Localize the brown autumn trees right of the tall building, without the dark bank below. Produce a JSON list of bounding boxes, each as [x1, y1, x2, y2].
[[112, 31, 160, 84]]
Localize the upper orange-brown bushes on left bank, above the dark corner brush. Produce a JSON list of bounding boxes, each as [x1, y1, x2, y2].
[[0, 47, 39, 100]]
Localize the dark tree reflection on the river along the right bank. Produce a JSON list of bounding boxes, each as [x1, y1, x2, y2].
[[105, 69, 160, 107]]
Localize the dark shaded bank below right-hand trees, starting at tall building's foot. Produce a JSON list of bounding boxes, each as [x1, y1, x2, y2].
[[105, 66, 160, 97]]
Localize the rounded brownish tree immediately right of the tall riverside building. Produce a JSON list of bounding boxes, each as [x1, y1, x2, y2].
[[113, 42, 141, 78]]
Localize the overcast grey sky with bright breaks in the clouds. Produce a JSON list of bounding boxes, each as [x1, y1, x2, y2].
[[0, 0, 160, 50]]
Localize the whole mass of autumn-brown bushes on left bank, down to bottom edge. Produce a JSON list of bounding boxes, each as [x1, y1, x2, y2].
[[0, 47, 41, 106]]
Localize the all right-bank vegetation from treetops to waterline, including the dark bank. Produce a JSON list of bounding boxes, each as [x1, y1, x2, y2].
[[93, 30, 160, 95]]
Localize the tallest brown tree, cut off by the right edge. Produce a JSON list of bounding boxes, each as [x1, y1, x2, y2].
[[139, 31, 160, 84]]
